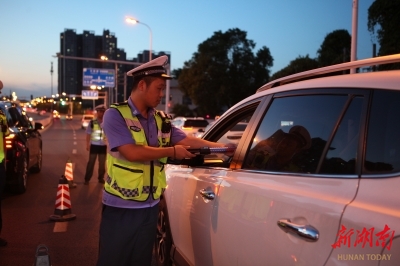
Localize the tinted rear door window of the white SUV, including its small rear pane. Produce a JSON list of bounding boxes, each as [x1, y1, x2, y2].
[[243, 95, 362, 174]]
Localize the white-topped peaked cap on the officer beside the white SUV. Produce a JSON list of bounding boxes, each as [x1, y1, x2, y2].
[[126, 55, 172, 79]]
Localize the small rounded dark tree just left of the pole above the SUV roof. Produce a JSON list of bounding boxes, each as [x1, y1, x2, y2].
[[317, 30, 351, 67]]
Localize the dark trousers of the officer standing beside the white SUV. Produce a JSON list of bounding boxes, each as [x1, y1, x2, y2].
[[97, 204, 158, 266]]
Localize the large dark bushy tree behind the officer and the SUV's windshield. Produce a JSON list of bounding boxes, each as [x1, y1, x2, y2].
[[178, 28, 273, 116]]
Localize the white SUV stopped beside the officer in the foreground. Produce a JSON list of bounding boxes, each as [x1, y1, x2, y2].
[[155, 54, 400, 266]]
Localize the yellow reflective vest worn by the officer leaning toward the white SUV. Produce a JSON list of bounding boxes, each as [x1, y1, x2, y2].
[[104, 102, 171, 201]]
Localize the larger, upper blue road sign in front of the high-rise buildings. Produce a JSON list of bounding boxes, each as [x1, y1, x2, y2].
[[83, 68, 115, 87]]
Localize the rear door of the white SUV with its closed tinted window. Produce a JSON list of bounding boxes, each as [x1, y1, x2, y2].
[[202, 89, 368, 265]]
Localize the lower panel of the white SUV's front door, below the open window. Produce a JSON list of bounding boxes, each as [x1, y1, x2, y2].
[[165, 165, 225, 265]]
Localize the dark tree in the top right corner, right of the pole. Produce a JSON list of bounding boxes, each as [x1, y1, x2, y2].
[[368, 0, 400, 69]]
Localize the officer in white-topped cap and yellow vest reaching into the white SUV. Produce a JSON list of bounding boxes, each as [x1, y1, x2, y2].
[[97, 56, 230, 266]]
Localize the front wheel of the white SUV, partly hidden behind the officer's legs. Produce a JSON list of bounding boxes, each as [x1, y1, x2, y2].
[[154, 199, 172, 266]]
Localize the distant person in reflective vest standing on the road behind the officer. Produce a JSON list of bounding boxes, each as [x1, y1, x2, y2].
[[85, 104, 107, 185]]
